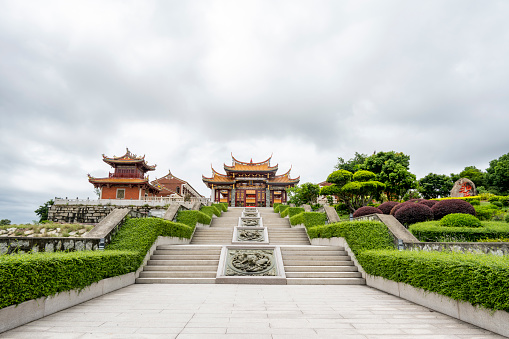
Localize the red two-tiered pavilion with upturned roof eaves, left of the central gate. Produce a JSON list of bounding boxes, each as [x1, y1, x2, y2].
[[88, 149, 159, 200]]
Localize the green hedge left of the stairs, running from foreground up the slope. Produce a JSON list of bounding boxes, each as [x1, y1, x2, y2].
[[0, 218, 193, 308]]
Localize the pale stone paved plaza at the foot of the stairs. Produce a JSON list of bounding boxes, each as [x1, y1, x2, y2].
[[0, 284, 504, 339]]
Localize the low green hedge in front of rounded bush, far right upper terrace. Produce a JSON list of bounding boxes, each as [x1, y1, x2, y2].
[[409, 221, 509, 242]]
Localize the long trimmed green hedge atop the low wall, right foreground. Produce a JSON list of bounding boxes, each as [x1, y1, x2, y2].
[[357, 250, 509, 311]]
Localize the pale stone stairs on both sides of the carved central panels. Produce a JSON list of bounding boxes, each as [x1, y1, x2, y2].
[[136, 207, 365, 285]]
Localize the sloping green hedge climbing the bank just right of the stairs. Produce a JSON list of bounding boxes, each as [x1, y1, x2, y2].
[[307, 221, 394, 256]]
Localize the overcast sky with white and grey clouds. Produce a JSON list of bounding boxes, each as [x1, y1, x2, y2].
[[0, 0, 509, 223]]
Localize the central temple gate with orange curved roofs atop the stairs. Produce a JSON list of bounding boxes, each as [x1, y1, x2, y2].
[[202, 154, 300, 207]]
